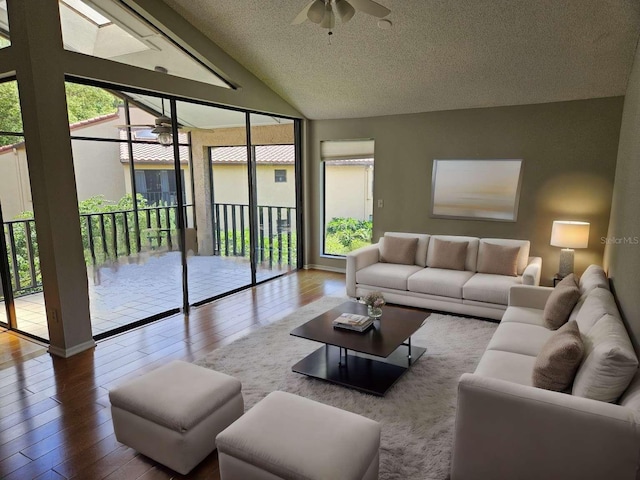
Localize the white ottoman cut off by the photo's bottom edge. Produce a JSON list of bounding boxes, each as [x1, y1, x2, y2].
[[216, 392, 380, 480]]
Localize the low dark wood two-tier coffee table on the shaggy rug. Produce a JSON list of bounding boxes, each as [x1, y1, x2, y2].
[[291, 302, 431, 396]]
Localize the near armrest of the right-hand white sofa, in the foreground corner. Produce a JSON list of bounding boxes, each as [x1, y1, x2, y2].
[[451, 374, 640, 480]]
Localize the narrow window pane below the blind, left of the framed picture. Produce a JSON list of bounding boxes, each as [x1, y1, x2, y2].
[[321, 140, 373, 256]]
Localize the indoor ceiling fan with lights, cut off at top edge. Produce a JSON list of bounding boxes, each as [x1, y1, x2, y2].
[[291, 0, 391, 29]]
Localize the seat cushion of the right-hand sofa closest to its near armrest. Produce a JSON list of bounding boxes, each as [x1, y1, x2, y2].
[[475, 350, 536, 387]]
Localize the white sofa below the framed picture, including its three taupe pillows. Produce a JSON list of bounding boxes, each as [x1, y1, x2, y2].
[[346, 232, 542, 320]]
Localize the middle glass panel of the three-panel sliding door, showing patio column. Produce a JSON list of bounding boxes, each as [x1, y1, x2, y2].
[[176, 102, 252, 304]]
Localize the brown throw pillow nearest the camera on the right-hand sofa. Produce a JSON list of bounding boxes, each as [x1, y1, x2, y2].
[[532, 321, 584, 392]]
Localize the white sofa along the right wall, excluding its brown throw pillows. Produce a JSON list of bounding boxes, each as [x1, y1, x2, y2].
[[451, 265, 640, 480]]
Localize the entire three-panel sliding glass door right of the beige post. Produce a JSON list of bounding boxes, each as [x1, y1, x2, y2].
[[67, 79, 300, 338]]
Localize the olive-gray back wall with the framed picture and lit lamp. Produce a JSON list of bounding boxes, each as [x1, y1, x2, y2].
[[306, 97, 623, 284]]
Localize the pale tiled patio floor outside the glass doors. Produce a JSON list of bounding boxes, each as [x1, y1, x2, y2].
[[0, 252, 289, 339]]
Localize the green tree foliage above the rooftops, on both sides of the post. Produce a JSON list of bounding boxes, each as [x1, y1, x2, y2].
[[0, 81, 120, 146]]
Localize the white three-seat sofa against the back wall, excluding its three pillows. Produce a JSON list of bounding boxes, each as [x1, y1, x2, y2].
[[346, 232, 542, 320]]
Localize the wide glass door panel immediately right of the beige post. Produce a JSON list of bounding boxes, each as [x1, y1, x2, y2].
[[67, 84, 182, 338]]
